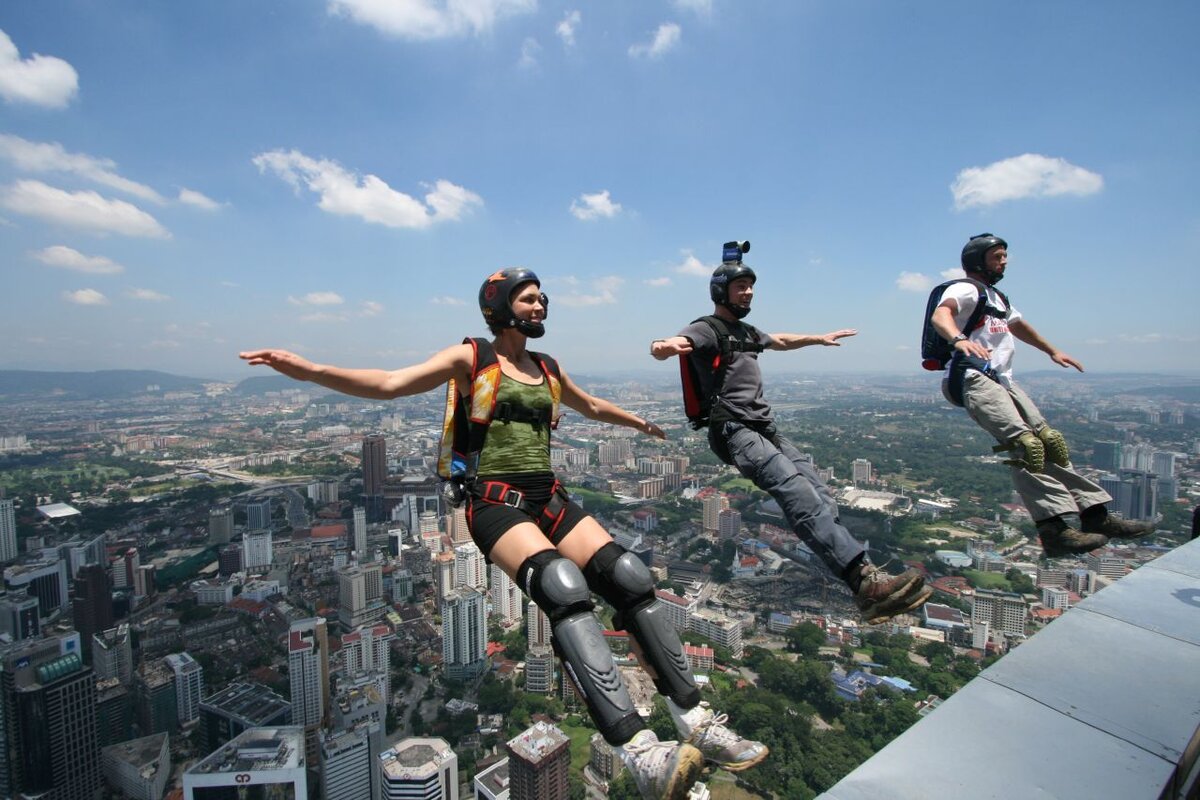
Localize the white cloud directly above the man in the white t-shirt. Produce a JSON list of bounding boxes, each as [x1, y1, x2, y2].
[[950, 152, 1104, 211]]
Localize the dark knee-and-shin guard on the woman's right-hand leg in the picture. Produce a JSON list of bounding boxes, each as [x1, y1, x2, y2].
[[583, 542, 700, 709]]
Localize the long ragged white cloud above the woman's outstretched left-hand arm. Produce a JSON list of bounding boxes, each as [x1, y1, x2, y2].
[[254, 150, 484, 228]]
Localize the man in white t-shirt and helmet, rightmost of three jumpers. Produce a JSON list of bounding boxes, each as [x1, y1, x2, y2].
[[930, 234, 1153, 557]]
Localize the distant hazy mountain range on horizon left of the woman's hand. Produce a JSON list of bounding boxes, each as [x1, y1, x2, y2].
[[0, 369, 329, 403]]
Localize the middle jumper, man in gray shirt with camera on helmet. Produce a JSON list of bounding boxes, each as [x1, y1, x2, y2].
[[650, 242, 931, 624]]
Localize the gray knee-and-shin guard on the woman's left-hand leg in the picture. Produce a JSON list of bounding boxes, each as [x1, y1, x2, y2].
[[517, 551, 646, 746]]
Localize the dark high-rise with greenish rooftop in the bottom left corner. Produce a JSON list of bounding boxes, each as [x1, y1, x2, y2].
[[0, 637, 101, 798]]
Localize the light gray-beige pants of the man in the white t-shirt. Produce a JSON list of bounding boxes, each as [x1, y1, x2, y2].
[[962, 369, 1112, 522]]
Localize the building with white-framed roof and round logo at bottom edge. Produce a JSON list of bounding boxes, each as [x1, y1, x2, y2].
[[184, 727, 317, 800]]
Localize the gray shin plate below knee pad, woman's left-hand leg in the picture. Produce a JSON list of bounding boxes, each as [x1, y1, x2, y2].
[[551, 613, 646, 747]]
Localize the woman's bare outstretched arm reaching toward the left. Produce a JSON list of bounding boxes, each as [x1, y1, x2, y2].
[[239, 344, 472, 399]]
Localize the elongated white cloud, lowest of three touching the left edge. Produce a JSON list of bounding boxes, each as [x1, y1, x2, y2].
[[0, 180, 170, 239]]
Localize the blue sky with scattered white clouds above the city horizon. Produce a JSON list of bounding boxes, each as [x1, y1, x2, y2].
[[0, 0, 1200, 379]]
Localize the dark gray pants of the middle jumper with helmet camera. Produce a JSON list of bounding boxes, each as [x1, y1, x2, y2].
[[709, 421, 864, 578]]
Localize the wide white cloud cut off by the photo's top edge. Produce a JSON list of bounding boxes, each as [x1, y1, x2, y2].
[[329, 0, 538, 40]]
